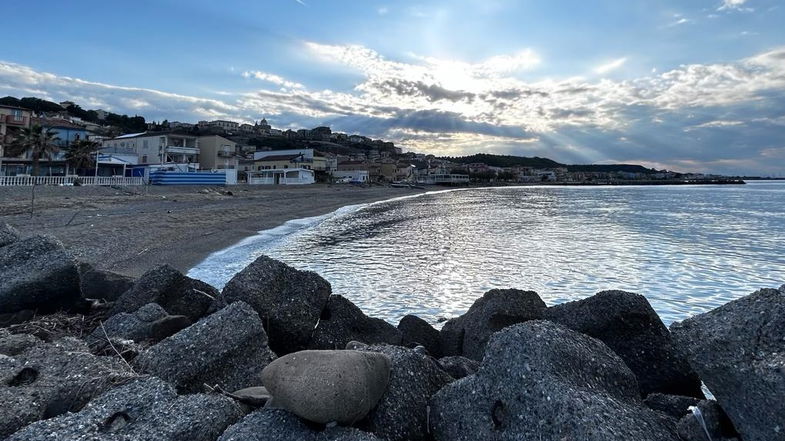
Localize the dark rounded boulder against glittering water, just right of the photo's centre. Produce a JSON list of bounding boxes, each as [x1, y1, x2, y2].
[[441, 289, 546, 360]]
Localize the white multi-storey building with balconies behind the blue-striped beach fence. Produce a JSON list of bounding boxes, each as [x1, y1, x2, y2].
[[101, 132, 199, 169]]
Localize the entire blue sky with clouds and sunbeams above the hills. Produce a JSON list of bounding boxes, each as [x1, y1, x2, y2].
[[0, 0, 785, 176]]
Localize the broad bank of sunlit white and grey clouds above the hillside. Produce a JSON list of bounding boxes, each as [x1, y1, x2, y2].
[[0, 42, 785, 174]]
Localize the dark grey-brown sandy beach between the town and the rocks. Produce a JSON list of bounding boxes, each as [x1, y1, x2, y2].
[[0, 185, 422, 276]]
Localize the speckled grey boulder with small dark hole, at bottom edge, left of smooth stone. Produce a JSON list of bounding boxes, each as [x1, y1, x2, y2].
[[7, 377, 242, 441]]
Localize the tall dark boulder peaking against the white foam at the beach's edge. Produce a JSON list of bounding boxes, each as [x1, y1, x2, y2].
[[217, 256, 334, 355]]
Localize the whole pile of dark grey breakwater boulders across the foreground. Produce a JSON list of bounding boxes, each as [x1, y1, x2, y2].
[[0, 222, 785, 441]]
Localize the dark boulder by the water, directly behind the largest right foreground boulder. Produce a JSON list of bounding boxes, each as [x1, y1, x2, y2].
[[545, 291, 703, 398]]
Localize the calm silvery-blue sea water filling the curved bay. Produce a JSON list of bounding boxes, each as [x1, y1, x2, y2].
[[189, 182, 785, 324]]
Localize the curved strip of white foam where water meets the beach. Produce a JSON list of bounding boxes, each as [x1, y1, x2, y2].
[[187, 189, 448, 289]]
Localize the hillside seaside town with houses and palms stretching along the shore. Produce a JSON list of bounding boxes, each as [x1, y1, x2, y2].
[[0, 97, 738, 186]]
